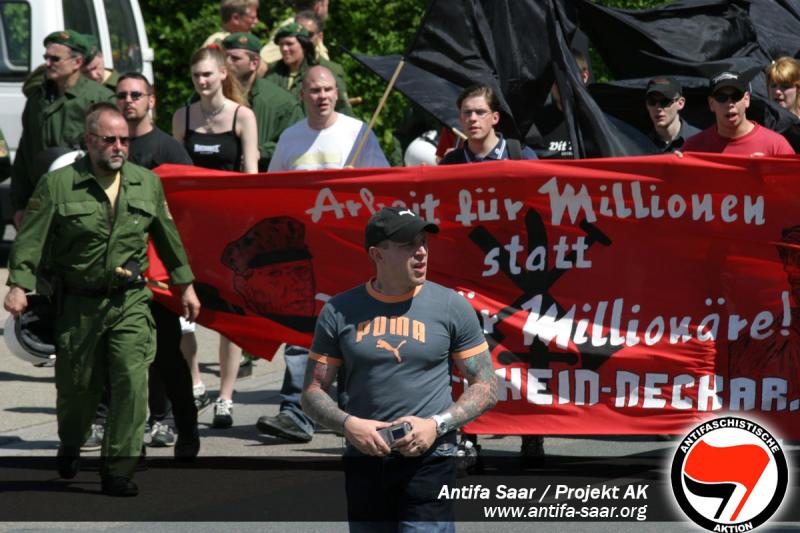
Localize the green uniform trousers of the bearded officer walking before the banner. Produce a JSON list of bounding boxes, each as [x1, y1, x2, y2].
[[55, 288, 156, 478]]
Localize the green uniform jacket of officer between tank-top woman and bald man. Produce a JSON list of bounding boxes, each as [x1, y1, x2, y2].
[[253, 77, 305, 168]]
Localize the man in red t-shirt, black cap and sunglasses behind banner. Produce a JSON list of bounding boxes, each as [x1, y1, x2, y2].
[[683, 71, 794, 156]]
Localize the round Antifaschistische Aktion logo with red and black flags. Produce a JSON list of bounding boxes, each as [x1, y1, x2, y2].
[[671, 416, 789, 533]]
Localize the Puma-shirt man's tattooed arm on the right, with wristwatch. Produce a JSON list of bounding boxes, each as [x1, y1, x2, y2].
[[394, 350, 497, 455]]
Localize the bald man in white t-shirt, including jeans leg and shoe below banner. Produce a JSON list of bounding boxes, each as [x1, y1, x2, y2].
[[256, 66, 389, 443]]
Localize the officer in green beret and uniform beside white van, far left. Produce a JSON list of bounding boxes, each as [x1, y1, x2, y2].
[[11, 30, 114, 227]]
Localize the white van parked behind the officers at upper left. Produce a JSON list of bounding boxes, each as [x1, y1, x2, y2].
[[0, 0, 153, 158]]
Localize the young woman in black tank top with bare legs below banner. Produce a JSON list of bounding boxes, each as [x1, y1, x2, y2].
[[172, 45, 259, 428]]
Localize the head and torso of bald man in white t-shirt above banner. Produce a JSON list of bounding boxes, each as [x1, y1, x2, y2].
[[269, 65, 389, 172]]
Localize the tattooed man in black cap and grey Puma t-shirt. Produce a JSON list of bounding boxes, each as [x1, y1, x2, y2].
[[302, 207, 497, 531]]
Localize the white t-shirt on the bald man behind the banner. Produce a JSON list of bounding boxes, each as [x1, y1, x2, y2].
[[268, 113, 389, 172]]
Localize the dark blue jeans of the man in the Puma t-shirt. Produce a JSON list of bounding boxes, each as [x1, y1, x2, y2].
[[344, 433, 456, 533]]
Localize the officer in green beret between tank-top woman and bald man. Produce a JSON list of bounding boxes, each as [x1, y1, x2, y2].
[[222, 33, 305, 172]]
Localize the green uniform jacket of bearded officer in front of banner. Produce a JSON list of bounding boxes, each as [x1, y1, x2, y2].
[[8, 157, 194, 292]]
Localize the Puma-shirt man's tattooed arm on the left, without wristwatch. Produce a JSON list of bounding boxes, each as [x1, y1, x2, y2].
[[300, 358, 391, 456]]
